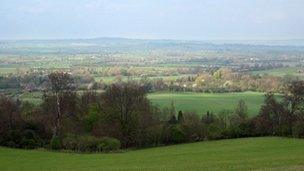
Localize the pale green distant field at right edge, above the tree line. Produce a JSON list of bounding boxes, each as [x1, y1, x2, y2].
[[251, 67, 304, 77]]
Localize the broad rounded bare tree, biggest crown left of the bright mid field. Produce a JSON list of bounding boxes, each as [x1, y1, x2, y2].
[[101, 82, 153, 147]]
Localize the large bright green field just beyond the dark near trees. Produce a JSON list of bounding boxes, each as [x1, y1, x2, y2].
[[148, 92, 264, 115]]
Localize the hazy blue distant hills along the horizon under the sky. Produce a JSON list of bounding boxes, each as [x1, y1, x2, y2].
[[0, 38, 304, 54]]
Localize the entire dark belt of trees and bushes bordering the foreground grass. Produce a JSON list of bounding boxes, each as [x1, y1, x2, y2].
[[0, 72, 304, 152]]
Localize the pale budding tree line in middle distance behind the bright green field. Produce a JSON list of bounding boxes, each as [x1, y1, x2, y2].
[[0, 67, 295, 94]]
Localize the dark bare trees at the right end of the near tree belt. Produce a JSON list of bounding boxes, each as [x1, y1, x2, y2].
[[257, 81, 304, 137]]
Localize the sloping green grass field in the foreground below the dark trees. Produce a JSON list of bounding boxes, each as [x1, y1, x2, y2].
[[0, 137, 304, 171]]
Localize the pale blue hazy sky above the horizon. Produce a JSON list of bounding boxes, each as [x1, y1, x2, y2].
[[0, 0, 304, 40]]
